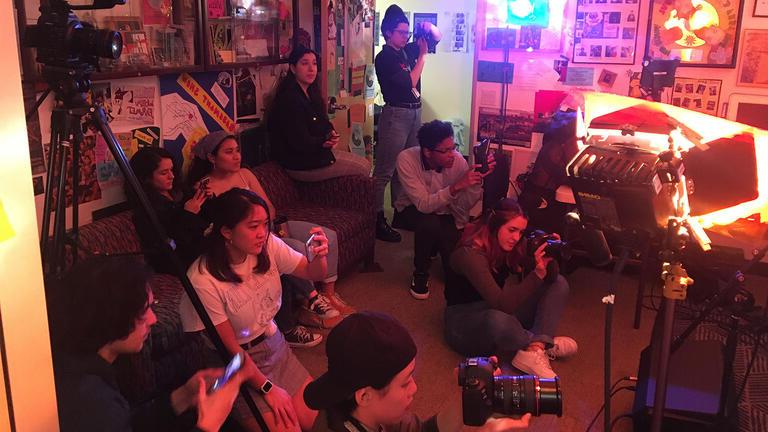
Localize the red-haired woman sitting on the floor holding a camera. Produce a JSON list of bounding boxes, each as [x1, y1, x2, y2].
[[445, 198, 578, 378]]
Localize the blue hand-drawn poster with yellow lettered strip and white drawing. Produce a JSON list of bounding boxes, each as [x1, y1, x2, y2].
[[160, 72, 235, 172]]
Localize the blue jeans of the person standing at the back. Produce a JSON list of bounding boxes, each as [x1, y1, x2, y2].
[[373, 105, 421, 212]]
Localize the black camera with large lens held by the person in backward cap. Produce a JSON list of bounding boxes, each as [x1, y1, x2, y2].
[[459, 357, 563, 426]]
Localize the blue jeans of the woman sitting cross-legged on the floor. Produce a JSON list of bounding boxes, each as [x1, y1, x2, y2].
[[445, 276, 570, 359]]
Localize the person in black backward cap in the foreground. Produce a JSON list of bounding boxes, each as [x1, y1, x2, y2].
[[304, 311, 531, 432]]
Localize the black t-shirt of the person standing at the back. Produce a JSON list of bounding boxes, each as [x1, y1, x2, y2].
[[375, 42, 421, 104]]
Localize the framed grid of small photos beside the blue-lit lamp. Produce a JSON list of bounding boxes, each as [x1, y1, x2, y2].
[[573, 0, 640, 64]]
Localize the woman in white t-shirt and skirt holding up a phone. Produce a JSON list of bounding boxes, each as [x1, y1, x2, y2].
[[179, 188, 328, 431]]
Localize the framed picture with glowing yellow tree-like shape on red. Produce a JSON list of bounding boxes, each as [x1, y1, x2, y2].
[[645, 0, 744, 68]]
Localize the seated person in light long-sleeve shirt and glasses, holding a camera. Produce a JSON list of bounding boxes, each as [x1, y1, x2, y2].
[[393, 120, 496, 300]]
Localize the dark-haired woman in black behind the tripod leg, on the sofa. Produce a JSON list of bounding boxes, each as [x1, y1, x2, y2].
[[126, 147, 210, 274]]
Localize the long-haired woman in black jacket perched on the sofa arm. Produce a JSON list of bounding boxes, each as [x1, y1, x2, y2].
[[267, 45, 371, 181]]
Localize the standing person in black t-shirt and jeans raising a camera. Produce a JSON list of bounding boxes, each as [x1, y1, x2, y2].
[[373, 5, 434, 243]]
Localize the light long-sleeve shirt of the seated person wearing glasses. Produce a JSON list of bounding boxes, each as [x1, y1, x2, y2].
[[395, 146, 483, 229]]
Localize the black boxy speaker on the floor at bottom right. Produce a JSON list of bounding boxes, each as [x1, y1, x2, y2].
[[632, 338, 723, 432]]
